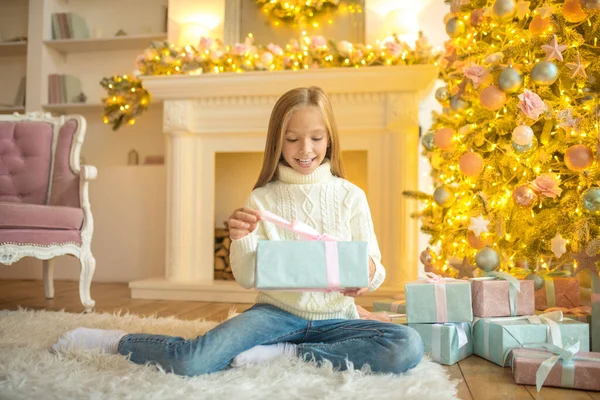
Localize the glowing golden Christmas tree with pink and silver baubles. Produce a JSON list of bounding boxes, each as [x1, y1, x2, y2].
[[405, 0, 600, 282]]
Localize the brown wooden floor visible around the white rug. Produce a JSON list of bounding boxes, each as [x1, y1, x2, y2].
[[0, 280, 600, 400]]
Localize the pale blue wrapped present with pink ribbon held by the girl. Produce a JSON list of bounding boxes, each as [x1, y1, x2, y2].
[[255, 211, 369, 291]]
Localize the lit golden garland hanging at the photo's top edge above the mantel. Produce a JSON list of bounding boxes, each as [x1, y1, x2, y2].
[[255, 0, 362, 25]]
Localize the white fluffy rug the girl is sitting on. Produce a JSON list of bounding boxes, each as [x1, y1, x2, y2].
[[0, 310, 457, 400]]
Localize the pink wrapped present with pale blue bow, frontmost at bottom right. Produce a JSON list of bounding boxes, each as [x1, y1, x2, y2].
[[512, 343, 600, 392]]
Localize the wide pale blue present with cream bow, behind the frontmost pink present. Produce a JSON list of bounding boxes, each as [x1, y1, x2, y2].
[[473, 311, 589, 366]]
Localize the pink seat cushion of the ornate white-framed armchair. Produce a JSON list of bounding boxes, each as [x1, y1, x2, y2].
[[0, 202, 83, 230]]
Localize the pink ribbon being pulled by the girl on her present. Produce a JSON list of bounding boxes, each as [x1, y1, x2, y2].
[[260, 210, 341, 289]]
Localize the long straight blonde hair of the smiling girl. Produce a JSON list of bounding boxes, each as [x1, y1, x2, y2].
[[254, 86, 346, 189]]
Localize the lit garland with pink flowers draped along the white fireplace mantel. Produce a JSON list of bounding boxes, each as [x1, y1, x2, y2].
[[101, 35, 439, 130]]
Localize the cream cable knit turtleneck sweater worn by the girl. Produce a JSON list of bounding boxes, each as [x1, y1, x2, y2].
[[230, 160, 385, 320]]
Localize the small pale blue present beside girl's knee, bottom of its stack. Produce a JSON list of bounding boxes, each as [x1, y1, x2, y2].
[[408, 322, 473, 365]]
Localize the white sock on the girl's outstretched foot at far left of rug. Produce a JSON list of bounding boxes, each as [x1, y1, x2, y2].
[[52, 328, 127, 354]]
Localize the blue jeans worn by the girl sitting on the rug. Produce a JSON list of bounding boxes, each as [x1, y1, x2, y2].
[[119, 304, 423, 376]]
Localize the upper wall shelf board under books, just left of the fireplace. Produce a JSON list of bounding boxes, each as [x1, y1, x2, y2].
[[44, 33, 167, 54]]
